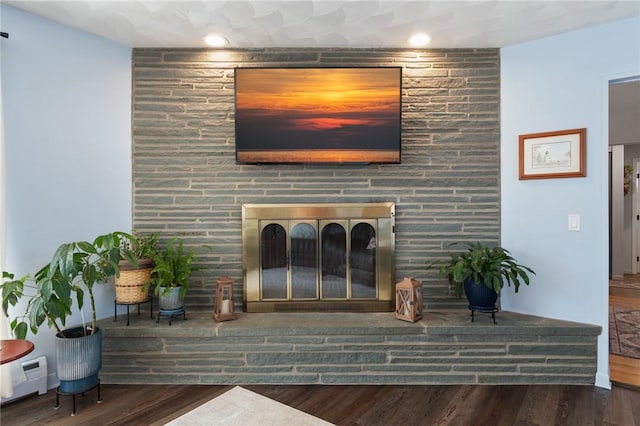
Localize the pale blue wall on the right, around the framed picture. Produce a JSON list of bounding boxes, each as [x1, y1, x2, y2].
[[501, 17, 640, 387]]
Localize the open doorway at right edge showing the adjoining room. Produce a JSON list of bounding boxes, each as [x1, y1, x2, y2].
[[609, 77, 640, 386]]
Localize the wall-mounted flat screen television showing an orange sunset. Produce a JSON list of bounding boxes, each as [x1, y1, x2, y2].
[[235, 67, 402, 164]]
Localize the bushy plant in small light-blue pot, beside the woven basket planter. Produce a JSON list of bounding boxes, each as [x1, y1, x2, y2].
[[151, 237, 199, 311]]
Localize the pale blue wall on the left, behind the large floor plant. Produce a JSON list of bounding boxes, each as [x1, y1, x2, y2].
[[0, 5, 131, 387]]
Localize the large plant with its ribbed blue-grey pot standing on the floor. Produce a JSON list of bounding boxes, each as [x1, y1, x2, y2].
[[1, 232, 128, 393]]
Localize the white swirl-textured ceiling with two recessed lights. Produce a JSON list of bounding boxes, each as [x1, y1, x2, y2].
[[2, 0, 640, 48]]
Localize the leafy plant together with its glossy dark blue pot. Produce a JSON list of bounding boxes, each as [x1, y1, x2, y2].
[[434, 242, 535, 311]]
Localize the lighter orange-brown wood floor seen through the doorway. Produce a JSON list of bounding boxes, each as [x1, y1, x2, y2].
[[609, 274, 640, 387]]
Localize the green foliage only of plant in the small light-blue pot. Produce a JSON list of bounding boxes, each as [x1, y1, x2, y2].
[[151, 237, 205, 298]]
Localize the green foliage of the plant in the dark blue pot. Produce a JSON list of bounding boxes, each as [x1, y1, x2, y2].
[[430, 242, 535, 297]]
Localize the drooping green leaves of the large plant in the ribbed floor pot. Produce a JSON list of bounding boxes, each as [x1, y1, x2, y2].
[[0, 232, 132, 339]]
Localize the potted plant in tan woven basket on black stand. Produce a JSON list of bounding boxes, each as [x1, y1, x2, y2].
[[115, 231, 159, 304]]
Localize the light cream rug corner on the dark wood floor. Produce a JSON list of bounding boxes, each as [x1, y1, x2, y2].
[[167, 386, 333, 426]]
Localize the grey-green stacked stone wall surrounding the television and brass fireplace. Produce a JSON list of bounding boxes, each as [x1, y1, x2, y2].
[[132, 48, 500, 309]]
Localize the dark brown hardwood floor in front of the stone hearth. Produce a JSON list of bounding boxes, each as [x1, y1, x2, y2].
[[0, 385, 640, 426]]
